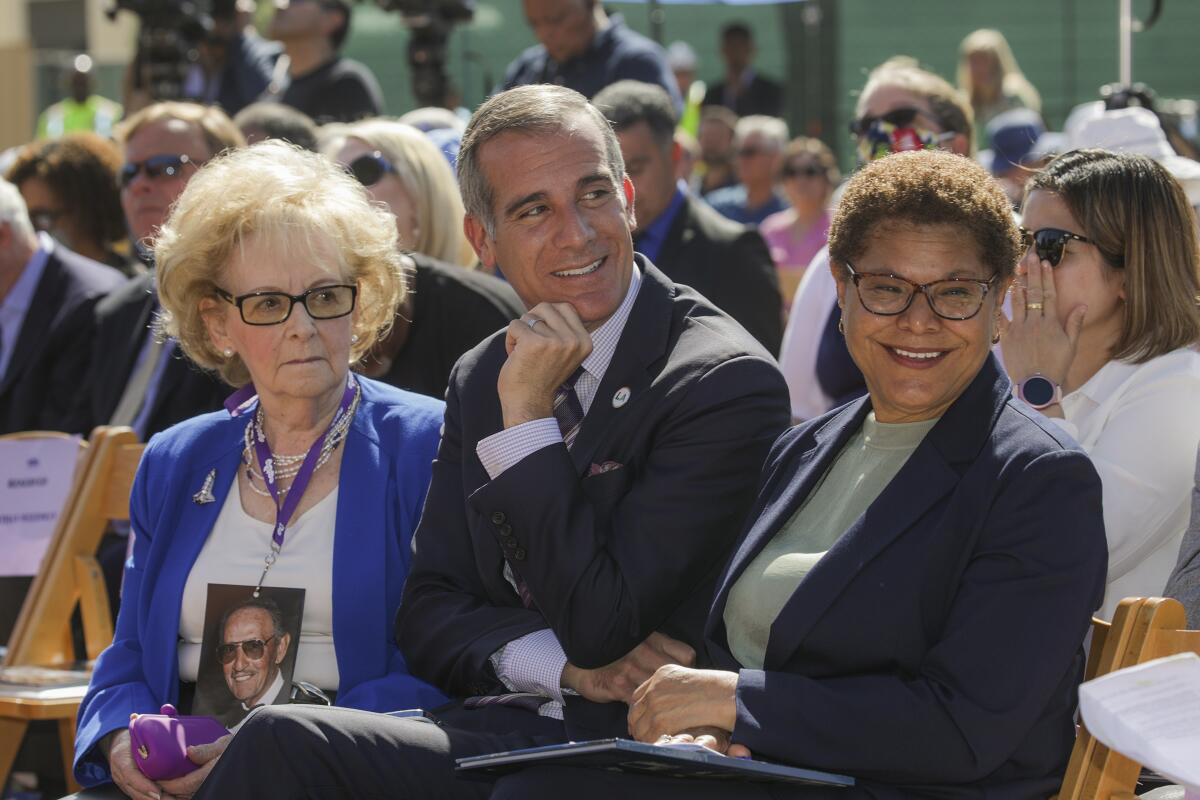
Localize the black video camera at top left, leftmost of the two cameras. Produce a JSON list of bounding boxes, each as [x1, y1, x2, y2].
[[104, 0, 213, 100]]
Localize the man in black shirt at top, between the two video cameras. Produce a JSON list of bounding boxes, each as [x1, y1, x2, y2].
[[269, 0, 383, 125]]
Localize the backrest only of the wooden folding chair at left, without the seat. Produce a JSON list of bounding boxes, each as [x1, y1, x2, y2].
[[5, 427, 144, 666]]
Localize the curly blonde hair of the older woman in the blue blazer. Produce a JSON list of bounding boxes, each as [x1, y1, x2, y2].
[[154, 142, 407, 386]]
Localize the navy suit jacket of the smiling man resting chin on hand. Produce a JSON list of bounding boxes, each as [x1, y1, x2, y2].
[[396, 261, 790, 736]]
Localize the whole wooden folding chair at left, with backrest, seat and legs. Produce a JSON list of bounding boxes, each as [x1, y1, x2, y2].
[[0, 427, 143, 792]]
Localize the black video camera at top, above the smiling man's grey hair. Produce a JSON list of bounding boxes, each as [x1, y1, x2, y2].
[[376, 0, 475, 107]]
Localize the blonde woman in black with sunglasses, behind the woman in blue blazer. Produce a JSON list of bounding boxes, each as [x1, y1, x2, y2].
[[323, 120, 524, 397]]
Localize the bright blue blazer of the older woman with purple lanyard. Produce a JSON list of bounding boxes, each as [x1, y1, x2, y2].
[[74, 377, 445, 786]]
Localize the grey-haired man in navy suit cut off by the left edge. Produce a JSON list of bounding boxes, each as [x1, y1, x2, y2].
[[0, 181, 125, 434]]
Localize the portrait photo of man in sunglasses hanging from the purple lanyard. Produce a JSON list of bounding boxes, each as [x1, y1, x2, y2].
[[194, 584, 304, 729]]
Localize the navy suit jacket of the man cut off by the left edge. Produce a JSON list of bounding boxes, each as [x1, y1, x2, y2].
[[0, 243, 125, 434]]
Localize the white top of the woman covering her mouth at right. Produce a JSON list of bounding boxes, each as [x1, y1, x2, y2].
[[1048, 348, 1200, 619]]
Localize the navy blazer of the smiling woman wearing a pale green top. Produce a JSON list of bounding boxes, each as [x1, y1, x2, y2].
[[707, 356, 1108, 798]]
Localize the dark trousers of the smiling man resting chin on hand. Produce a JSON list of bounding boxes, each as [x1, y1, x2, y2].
[[196, 704, 565, 800]]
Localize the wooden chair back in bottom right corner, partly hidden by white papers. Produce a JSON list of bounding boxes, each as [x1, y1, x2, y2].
[[1057, 597, 1200, 800]]
